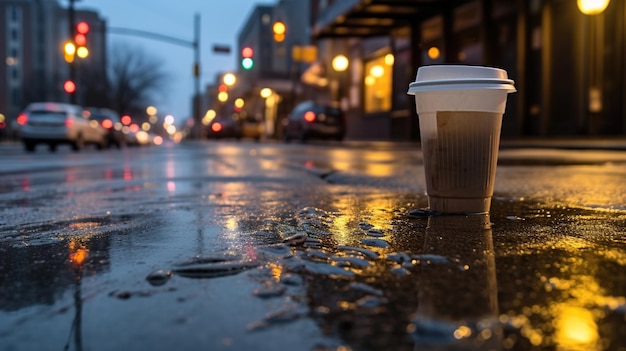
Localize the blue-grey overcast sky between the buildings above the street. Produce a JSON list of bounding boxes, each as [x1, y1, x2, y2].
[[78, 0, 276, 120]]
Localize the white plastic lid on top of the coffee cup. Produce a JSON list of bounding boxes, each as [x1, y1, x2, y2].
[[407, 65, 516, 95]]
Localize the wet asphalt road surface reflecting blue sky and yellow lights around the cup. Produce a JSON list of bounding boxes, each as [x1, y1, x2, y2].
[[0, 141, 626, 350]]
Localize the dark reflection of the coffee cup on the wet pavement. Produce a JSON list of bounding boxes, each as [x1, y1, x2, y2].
[[413, 214, 502, 350]]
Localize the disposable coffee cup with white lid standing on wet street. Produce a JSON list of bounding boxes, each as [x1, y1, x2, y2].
[[408, 65, 516, 213]]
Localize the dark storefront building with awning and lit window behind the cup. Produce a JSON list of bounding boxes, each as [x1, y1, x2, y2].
[[312, 0, 626, 140]]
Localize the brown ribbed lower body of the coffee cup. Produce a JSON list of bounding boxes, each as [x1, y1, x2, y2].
[[420, 111, 502, 213]]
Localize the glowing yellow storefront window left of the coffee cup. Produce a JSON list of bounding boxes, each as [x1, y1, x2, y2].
[[364, 54, 394, 113]]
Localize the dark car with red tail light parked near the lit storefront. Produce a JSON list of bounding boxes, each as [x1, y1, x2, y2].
[[283, 101, 346, 142]]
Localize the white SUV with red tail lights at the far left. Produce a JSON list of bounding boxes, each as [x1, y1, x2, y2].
[[17, 102, 107, 152]]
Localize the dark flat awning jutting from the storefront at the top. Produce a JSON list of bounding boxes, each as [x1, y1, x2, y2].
[[313, 0, 464, 39]]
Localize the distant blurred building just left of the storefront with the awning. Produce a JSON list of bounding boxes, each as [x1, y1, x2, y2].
[[202, 0, 316, 138]]
